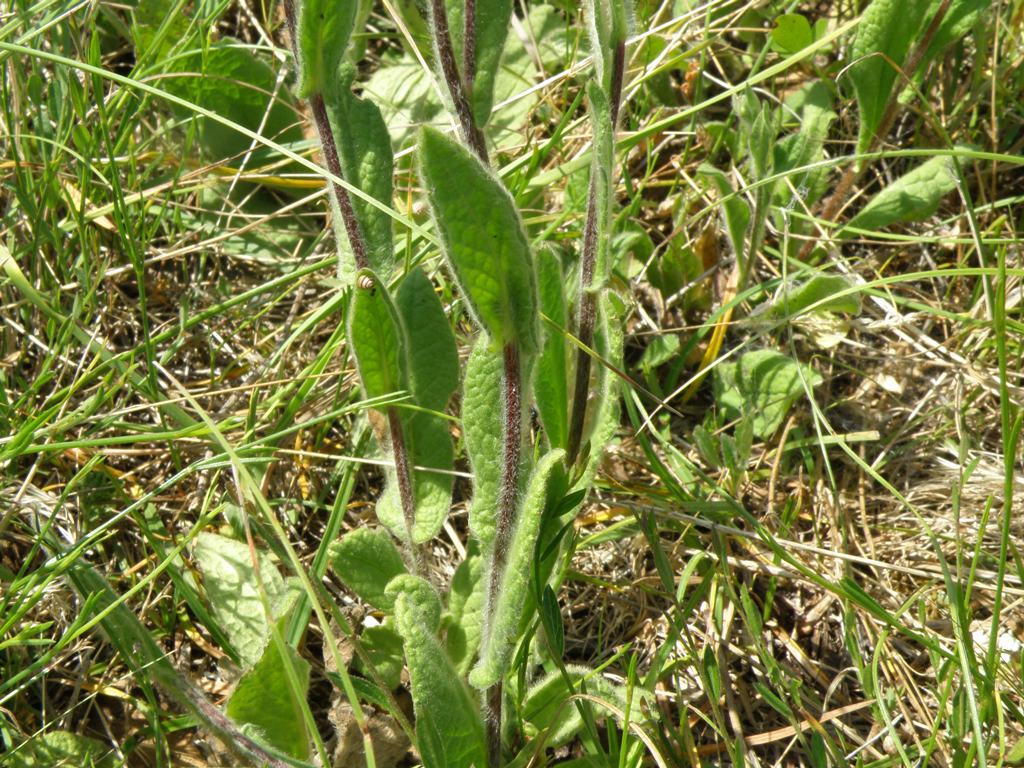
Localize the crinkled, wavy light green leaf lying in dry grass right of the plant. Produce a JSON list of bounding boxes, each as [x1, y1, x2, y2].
[[715, 349, 822, 438]]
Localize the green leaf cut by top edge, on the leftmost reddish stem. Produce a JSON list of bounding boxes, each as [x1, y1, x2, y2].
[[296, 0, 358, 98]]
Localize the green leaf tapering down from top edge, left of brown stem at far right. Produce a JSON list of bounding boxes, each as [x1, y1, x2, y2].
[[850, 0, 930, 152]]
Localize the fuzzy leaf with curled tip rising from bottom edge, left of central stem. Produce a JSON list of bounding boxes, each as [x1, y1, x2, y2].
[[388, 574, 486, 768]]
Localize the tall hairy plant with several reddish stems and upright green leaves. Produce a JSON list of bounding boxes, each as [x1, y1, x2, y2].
[[264, 0, 627, 766]]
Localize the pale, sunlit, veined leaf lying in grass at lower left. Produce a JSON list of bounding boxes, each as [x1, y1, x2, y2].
[[194, 532, 295, 669]]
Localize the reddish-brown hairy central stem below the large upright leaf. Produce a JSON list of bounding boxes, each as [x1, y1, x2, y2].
[[484, 342, 522, 768]]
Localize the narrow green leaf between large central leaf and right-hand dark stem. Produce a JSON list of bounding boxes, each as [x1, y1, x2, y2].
[[534, 249, 569, 449]]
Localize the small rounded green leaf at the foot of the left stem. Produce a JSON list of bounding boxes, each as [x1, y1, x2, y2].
[[328, 528, 406, 610]]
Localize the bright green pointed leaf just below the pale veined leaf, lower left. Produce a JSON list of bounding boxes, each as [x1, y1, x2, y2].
[[226, 643, 309, 760]]
